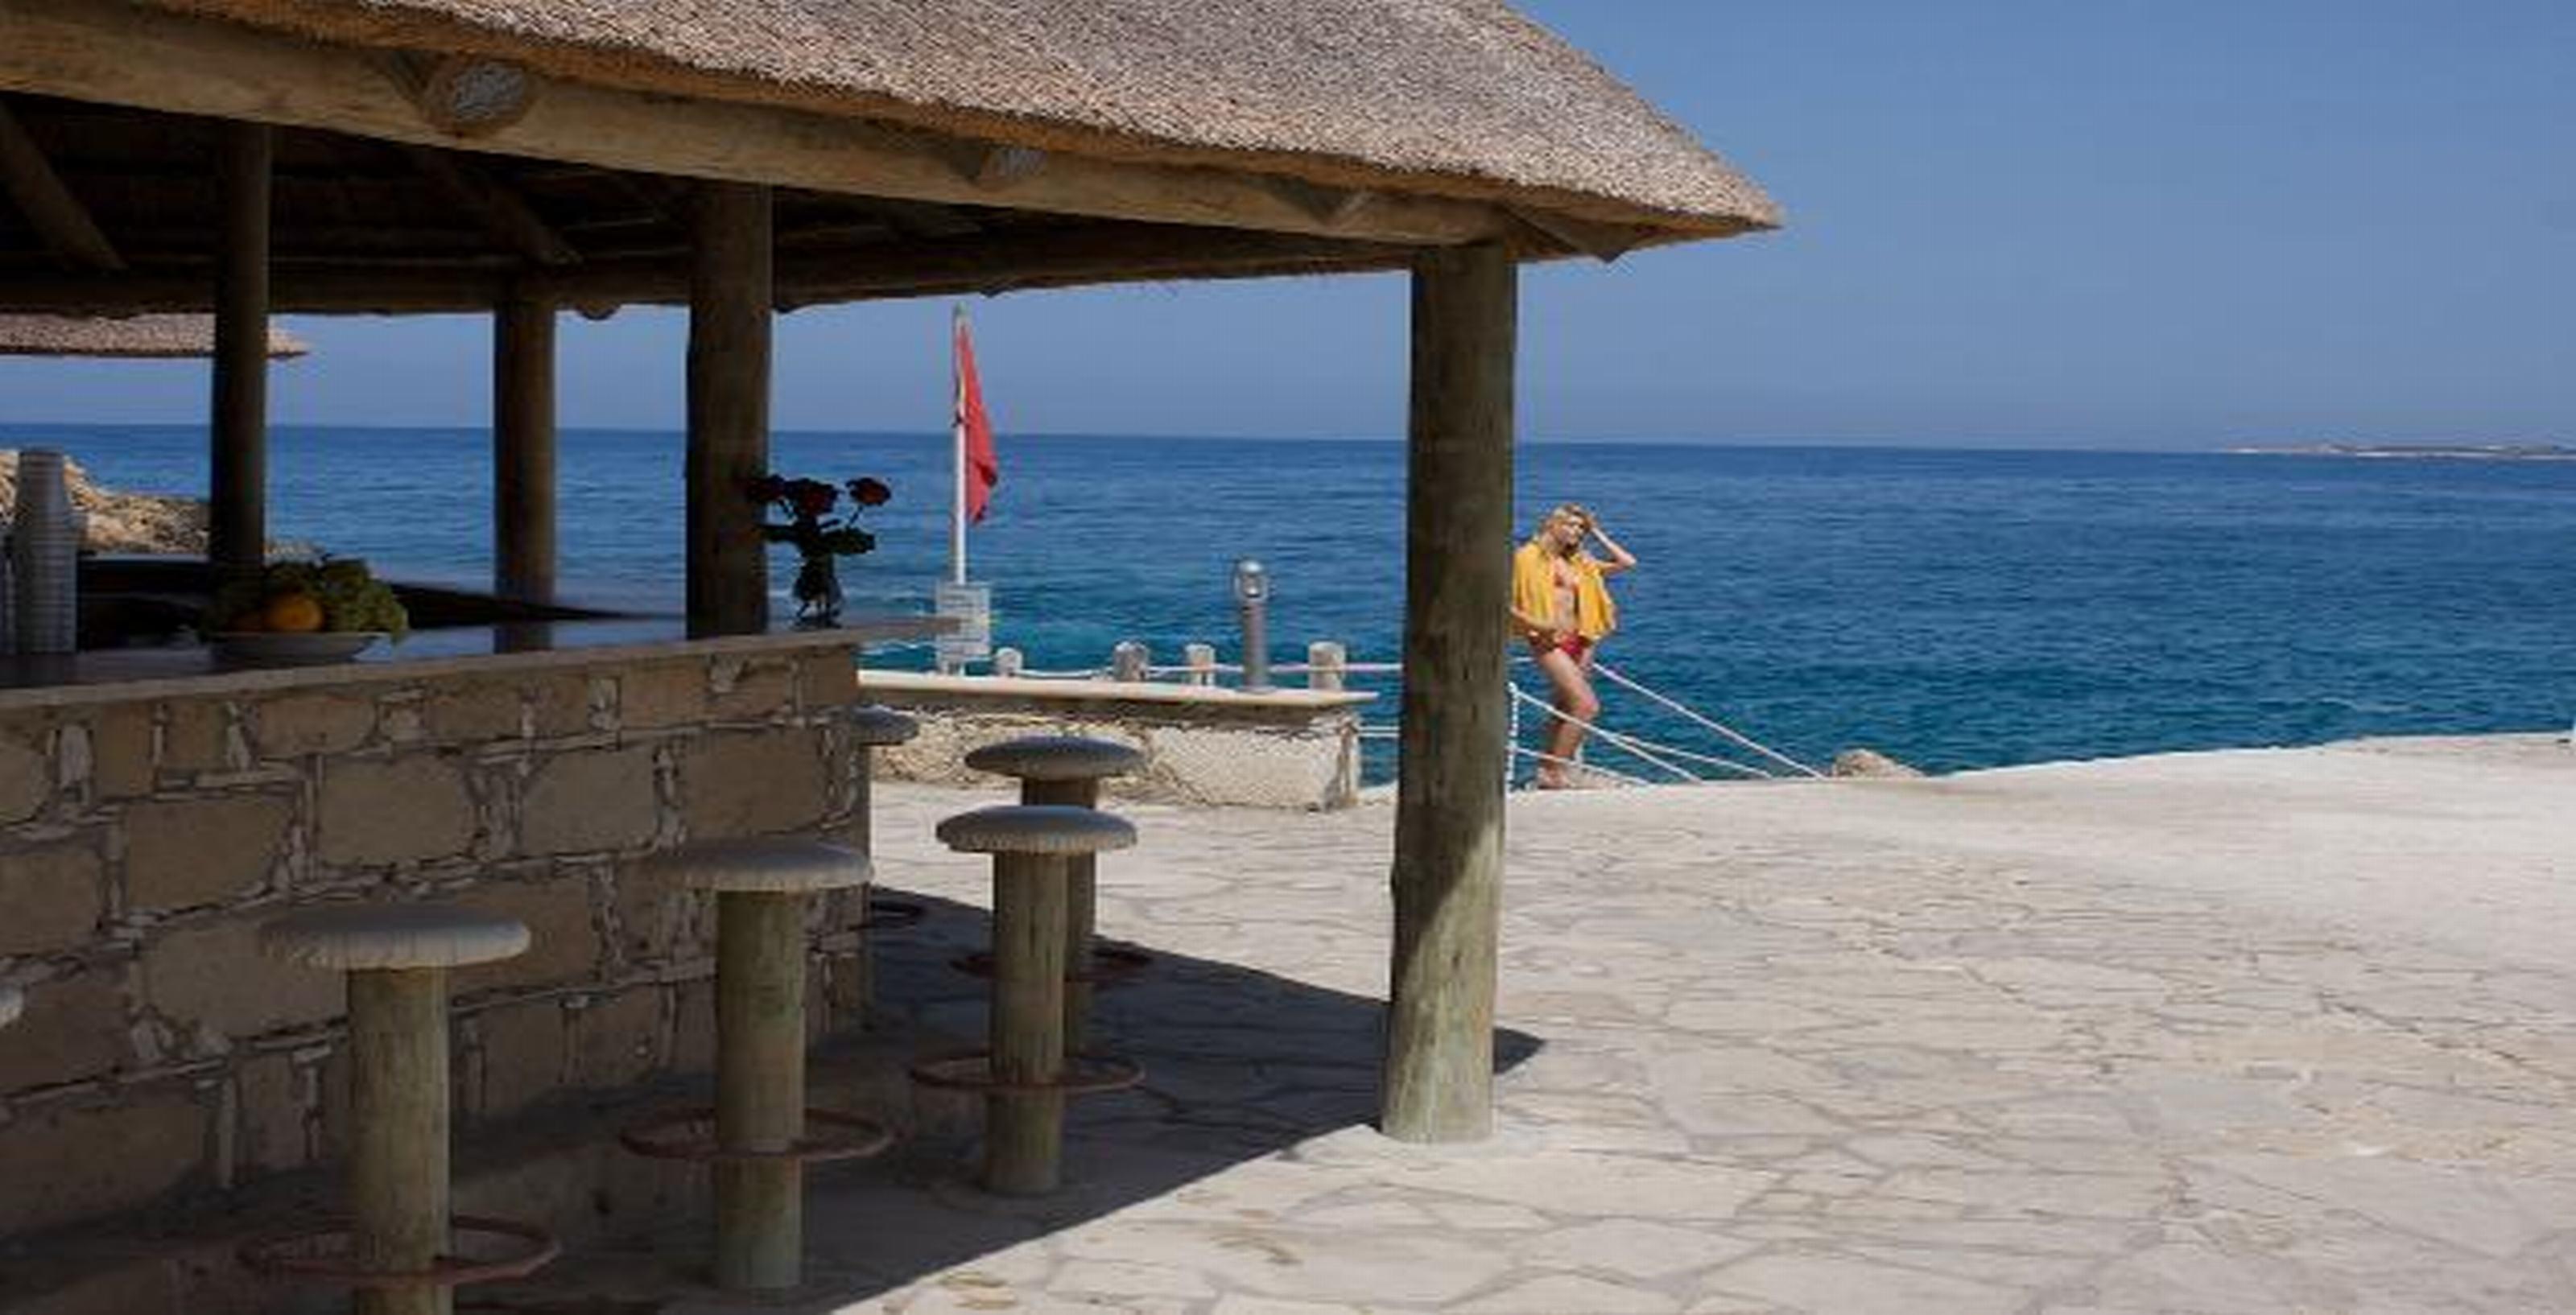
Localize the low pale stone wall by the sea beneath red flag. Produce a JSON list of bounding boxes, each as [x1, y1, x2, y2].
[[861, 672, 1376, 808]]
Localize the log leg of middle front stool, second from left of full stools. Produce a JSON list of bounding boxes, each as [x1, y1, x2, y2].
[[716, 890, 807, 1292]]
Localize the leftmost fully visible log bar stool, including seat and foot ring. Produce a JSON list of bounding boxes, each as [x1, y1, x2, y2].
[[240, 903, 559, 1315]]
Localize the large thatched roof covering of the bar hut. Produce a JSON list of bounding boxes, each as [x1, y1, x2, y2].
[[147, 0, 1777, 234]]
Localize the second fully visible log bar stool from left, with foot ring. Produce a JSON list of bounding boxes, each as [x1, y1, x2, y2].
[[618, 839, 894, 1292]]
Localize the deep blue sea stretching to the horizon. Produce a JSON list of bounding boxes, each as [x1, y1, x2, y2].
[[25, 425, 2576, 774]]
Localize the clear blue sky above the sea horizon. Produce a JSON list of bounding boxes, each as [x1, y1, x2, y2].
[[0, 0, 2576, 447]]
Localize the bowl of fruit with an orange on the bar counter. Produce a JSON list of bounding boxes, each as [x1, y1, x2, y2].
[[206, 559, 412, 666]]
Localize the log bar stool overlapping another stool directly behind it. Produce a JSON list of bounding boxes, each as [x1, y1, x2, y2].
[[912, 806, 1144, 1197]]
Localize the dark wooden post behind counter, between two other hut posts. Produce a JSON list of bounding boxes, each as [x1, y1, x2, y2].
[[492, 296, 556, 602]]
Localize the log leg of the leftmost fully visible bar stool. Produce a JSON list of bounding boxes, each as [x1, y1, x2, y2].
[[348, 967, 453, 1315]]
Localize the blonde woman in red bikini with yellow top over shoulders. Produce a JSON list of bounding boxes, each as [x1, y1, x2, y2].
[[1512, 502, 1636, 790]]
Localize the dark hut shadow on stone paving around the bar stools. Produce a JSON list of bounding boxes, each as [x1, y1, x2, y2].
[[473, 890, 1541, 1315]]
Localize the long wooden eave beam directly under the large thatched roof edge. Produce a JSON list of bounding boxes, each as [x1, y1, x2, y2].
[[0, 0, 1517, 245]]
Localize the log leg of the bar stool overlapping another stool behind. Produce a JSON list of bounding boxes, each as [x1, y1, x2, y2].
[[984, 855, 1069, 1197]]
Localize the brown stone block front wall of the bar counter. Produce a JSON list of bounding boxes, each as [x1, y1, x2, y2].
[[0, 643, 865, 1235]]
